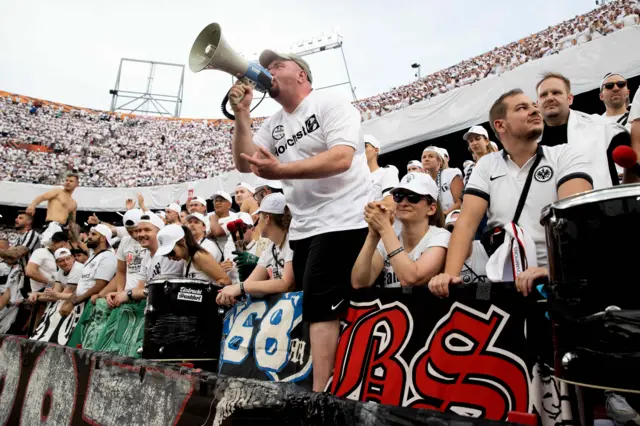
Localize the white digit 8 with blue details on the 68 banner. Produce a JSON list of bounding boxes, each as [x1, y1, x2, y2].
[[253, 292, 302, 380]]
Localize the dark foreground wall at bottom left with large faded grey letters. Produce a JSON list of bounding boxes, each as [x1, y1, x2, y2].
[[0, 336, 524, 426]]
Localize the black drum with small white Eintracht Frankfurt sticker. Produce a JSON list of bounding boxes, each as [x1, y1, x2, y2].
[[142, 278, 222, 360]]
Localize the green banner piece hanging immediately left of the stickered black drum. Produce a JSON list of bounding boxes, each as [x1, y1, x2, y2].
[[94, 300, 147, 358]]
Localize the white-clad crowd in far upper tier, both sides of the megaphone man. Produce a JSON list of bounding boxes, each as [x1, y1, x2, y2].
[[0, 0, 640, 187]]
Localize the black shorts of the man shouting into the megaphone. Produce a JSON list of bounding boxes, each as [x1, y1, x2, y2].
[[289, 228, 369, 322]]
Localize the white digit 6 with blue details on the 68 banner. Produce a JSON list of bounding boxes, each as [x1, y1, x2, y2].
[[220, 300, 267, 364]]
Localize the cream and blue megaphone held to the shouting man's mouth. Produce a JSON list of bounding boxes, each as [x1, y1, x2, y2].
[[189, 23, 271, 93]]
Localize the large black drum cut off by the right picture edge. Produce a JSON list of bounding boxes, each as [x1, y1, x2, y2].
[[541, 185, 640, 390]]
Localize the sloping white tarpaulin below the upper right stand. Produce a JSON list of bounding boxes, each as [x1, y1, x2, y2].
[[362, 26, 640, 152]]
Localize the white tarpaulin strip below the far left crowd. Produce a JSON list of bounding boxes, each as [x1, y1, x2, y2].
[[0, 170, 257, 212]]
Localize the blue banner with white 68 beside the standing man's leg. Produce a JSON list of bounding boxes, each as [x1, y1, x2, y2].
[[219, 292, 312, 389]]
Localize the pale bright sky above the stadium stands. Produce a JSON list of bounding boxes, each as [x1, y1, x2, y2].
[[0, 0, 595, 118]]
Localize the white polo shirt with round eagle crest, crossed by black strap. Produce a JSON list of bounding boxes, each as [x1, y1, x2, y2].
[[465, 144, 593, 267]]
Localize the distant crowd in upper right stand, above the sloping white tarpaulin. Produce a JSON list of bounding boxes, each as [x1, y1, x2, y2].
[[356, 0, 640, 120]]
